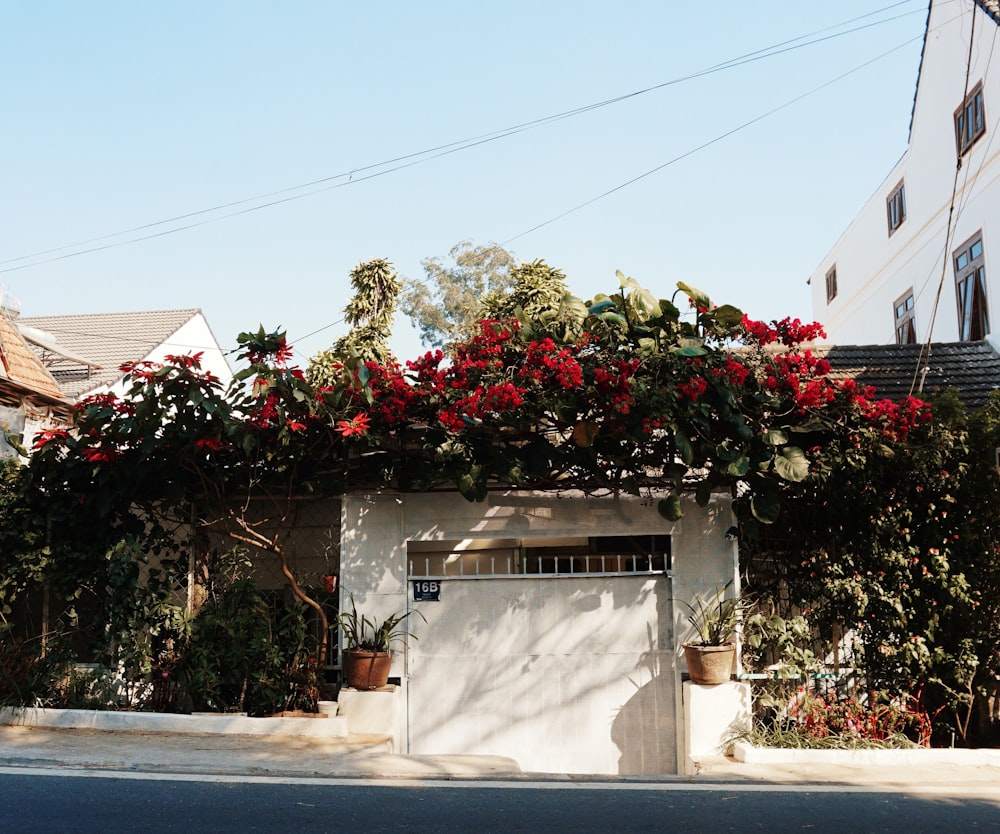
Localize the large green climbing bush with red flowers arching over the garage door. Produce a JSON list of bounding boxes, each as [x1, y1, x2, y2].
[[0, 261, 995, 740]]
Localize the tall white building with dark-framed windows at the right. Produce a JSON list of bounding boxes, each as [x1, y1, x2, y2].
[[810, 0, 1000, 344]]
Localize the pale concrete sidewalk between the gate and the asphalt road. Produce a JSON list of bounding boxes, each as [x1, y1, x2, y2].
[[0, 725, 1000, 788]]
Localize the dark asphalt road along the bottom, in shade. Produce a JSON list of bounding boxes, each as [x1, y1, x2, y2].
[[0, 770, 1000, 834]]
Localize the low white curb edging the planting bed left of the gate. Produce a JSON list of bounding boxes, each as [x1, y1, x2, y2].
[[0, 707, 348, 738]]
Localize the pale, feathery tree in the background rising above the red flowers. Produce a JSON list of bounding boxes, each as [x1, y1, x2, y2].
[[400, 240, 517, 348]]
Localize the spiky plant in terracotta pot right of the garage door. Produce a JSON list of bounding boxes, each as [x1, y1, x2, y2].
[[682, 585, 746, 685]]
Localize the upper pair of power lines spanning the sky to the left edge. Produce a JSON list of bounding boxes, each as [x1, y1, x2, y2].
[[0, 0, 913, 274]]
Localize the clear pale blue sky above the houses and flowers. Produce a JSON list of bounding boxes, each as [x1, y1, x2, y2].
[[0, 0, 927, 359]]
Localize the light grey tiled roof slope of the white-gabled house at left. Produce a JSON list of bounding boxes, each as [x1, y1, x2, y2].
[[18, 309, 201, 399]]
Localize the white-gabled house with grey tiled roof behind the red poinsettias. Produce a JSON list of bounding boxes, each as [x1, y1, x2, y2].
[[17, 309, 232, 400]]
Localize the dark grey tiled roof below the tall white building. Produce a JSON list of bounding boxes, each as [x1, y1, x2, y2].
[[813, 341, 1000, 408]]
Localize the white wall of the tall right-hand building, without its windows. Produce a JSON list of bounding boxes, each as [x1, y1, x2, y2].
[[810, 0, 1000, 344]]
